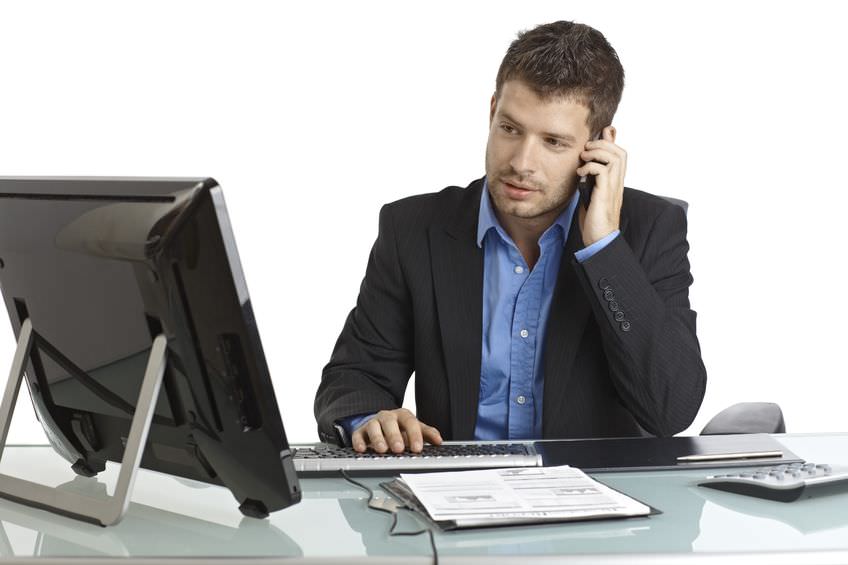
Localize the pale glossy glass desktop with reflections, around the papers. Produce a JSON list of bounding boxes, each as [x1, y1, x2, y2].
[[0, 434, 848, 563]]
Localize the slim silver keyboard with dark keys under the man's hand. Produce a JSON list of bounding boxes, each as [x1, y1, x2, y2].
[[294, 442, 542, 476]]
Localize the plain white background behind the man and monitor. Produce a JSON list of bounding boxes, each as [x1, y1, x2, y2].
[[0, 0, 848, 442]]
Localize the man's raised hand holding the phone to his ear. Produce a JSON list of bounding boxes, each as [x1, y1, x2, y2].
[[577, 126, 627, 246]]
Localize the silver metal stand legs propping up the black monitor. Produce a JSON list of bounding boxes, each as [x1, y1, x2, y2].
[[0, 319, 168, 526]]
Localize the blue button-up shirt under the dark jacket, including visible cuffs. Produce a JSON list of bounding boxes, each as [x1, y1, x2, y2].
[[340, 177, 619, 440]]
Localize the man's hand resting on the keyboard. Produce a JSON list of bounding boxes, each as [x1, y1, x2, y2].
[[351, 408, 442, 453]]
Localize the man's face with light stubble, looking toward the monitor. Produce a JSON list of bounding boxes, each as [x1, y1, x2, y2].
[[486, 80, 590, 227]]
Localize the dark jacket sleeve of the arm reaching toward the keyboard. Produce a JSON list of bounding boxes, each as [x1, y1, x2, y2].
[[314, 205, 413, 442]]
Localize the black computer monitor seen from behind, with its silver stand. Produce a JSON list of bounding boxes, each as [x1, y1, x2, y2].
[[0, 178, 300, 525]]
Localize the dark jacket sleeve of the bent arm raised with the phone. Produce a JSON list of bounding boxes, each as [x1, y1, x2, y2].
[[575, 205, 707, 436]]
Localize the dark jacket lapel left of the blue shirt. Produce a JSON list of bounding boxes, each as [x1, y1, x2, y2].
[[430, 179, 483, 440]]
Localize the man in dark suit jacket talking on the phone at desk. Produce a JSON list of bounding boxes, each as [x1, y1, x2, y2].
[[315, 22, 706, 452]]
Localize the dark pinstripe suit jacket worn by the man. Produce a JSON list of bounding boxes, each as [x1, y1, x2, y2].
[[315, 179, 706, 441]]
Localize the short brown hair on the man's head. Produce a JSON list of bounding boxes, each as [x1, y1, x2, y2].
[[495, 21, 624, 135]]
